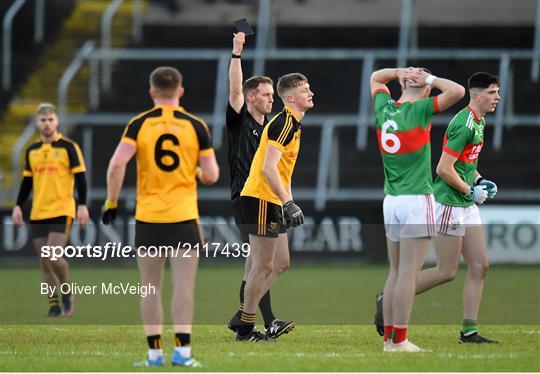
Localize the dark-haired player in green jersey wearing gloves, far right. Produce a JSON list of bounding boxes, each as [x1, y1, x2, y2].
[[375, 72, 500, 344]]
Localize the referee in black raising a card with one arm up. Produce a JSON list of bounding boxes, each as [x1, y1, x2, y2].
[[226, 32, 294, 338]]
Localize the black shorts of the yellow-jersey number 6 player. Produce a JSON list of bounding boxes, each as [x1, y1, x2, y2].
[[135, 219, 203, 249]]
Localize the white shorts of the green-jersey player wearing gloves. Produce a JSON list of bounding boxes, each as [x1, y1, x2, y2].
[[435, 202, 482, 236]]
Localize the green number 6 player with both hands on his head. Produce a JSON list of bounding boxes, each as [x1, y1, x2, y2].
[[370, 67, 465, 352]]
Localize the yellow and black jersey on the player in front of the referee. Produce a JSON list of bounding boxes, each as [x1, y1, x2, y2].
[[240, 106, 302, 205]]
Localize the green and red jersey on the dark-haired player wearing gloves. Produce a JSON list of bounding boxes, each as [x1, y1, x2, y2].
[[434, 106, 486, 207]]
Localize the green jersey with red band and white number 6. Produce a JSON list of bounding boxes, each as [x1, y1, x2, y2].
[[372, 89, 439, 196]]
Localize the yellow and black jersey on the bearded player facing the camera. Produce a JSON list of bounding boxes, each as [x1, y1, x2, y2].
[[23, 134, 86, 220]]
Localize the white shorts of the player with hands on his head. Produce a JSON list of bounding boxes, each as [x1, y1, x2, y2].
[[383, 195, 436, 242]]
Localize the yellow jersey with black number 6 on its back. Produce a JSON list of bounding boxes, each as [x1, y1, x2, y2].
[[121, 105, 214, 223]]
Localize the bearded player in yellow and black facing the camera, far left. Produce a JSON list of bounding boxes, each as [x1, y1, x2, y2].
[[12, 103, 89, 317]]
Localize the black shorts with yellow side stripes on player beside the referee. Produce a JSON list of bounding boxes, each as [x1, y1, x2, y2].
[[240, 196, 287, 238]]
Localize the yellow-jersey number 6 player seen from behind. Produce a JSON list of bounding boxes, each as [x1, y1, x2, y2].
[[102, 67, 219, 367]]
